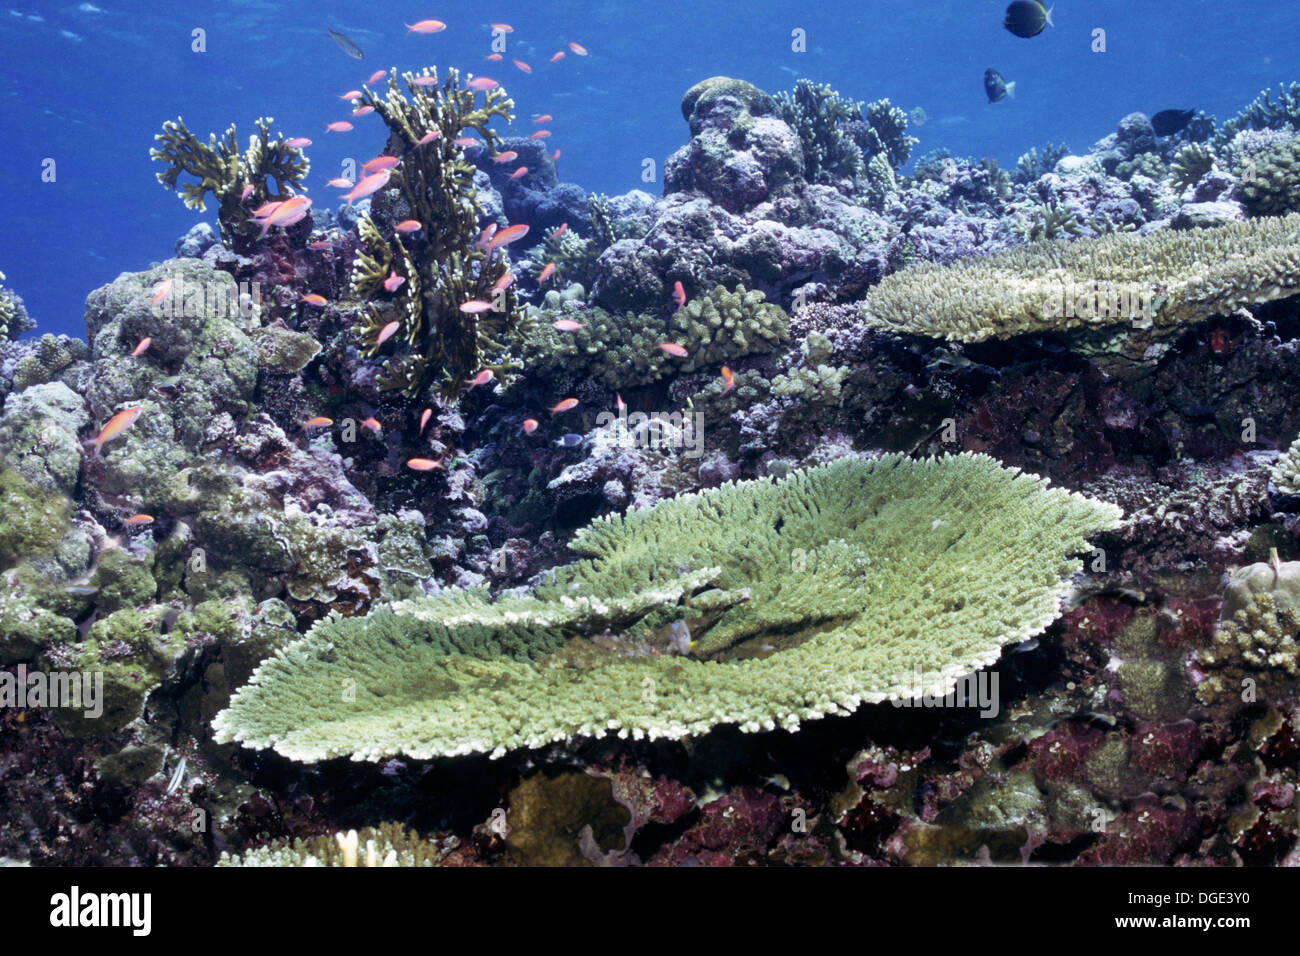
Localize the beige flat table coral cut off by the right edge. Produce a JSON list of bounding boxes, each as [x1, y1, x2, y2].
[[863, 215, 1300, 342]]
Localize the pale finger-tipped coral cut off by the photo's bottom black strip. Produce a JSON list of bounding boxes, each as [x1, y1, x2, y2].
[[217, 823, 446, 866]]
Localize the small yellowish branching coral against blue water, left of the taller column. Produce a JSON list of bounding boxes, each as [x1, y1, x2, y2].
[[150, 117, 311, 246]]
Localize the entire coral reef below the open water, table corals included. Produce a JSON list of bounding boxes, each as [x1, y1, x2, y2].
[[0, 9, 1300, 874]]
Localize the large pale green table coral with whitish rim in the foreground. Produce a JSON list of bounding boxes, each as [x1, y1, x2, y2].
[[213, 454, 1119, 761]]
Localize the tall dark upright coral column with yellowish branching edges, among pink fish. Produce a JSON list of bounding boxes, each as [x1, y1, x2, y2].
[[351, 69, 519, 398]]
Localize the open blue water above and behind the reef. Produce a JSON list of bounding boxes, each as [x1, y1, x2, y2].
[[0, 0, 1300, 336]]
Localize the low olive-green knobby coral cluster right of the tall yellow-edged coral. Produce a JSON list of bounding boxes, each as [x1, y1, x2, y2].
[[523, 285, 789, 389]]
